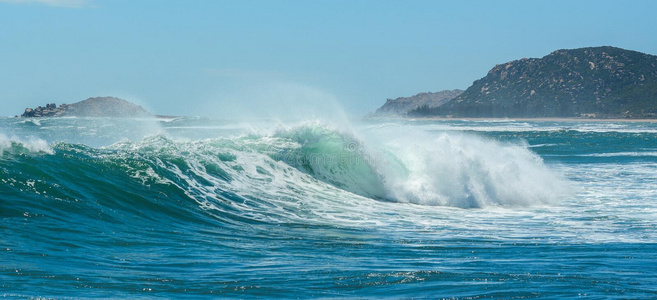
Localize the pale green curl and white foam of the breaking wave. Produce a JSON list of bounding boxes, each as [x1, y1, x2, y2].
[[266, 124, 570, 208]]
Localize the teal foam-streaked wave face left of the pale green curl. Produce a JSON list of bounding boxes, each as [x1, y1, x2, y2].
[[0, 136, 354, 233]]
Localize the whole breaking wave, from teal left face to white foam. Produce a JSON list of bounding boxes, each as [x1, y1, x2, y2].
[[0, 123, 568, 220]]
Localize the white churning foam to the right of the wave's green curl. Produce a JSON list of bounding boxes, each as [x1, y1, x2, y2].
[[378, 132, 569, 208]]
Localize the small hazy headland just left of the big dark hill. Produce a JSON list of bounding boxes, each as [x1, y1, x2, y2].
[[374, 90, 463, 116]]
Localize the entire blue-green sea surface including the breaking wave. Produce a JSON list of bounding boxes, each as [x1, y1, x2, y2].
[[0, 118, 657, 299]]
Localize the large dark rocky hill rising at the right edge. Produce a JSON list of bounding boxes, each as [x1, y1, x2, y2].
[[409, 47, 657, 118]]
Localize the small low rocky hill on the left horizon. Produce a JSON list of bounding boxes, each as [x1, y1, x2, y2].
[[21, 97, 152, 118]]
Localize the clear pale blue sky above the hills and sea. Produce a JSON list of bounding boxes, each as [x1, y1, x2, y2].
[[0, 0, 657, 117]]
